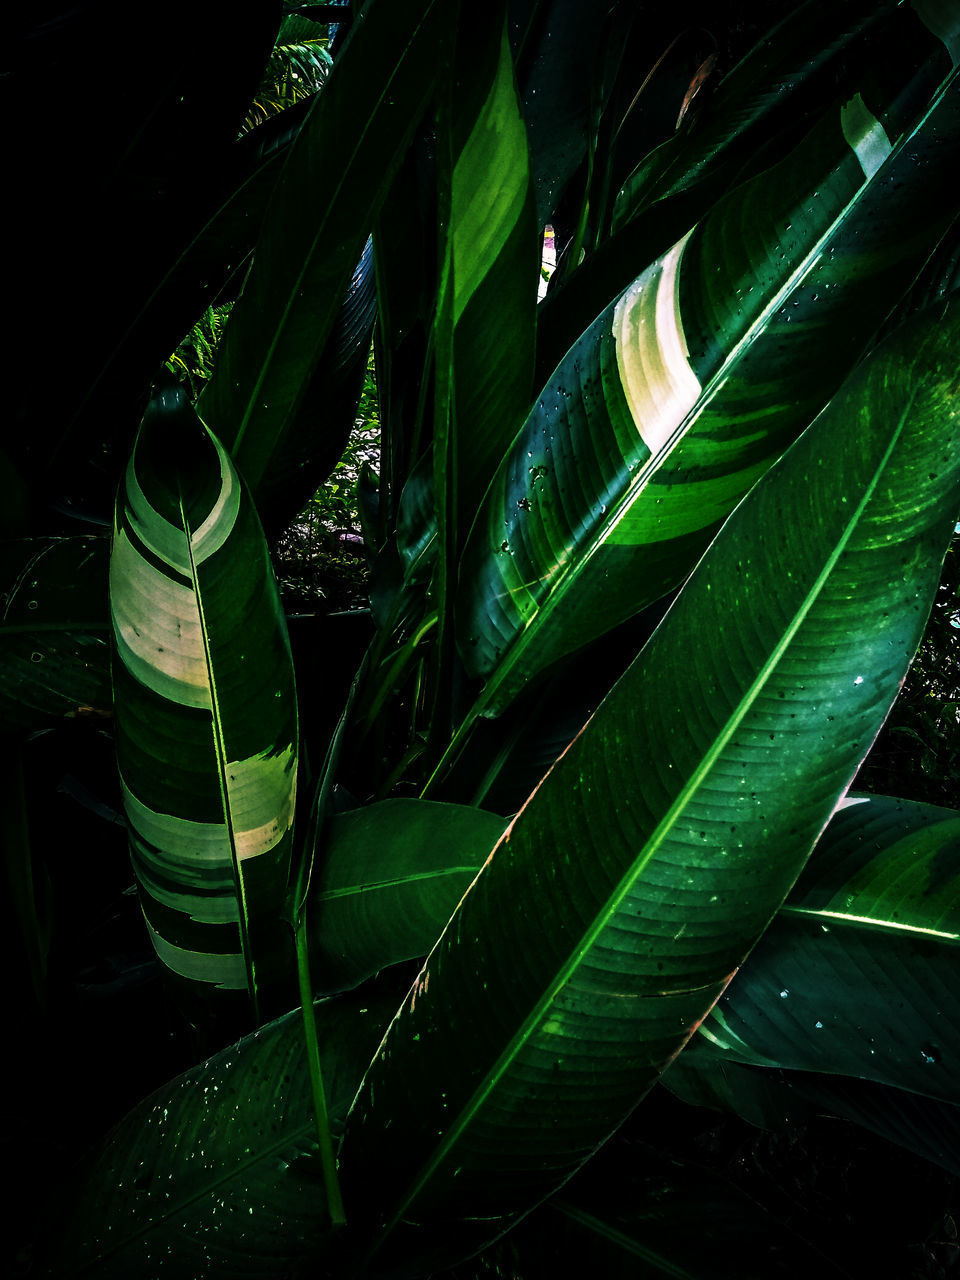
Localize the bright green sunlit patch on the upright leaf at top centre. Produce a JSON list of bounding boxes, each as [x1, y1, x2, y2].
[[451, 20, 527, 324]]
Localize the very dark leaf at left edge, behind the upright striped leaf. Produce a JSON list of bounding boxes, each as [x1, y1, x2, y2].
[[0, 538, 113, 732]]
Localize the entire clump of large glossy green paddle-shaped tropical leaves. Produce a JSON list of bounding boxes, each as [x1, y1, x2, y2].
[[0, 0, 960, 1276]]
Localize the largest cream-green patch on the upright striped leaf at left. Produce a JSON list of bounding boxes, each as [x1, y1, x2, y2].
[[110, 525, 210, 709]]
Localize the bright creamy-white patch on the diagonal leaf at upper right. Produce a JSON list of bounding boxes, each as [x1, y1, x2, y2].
[[613, 232, 700, 453]]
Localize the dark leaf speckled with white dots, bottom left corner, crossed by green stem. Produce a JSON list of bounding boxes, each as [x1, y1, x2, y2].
[[50, 991, 397, 1280]]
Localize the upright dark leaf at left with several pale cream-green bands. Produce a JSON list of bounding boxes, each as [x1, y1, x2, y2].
[[110, 390, 297, 992]]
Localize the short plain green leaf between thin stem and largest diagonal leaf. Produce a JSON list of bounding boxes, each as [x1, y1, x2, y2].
[[310, 800, 506, 995]]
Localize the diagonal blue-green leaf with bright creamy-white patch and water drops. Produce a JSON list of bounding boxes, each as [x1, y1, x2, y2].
[[457, 40, 960, 714]]
